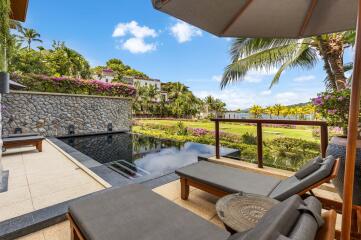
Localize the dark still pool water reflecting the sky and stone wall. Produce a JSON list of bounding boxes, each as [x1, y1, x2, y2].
[[60, 133, 236, 179]]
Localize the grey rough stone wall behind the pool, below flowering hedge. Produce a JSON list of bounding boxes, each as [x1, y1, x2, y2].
[[2, 91, 132, 136]]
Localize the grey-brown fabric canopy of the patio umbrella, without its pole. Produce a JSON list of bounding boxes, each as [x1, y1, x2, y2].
[[153, 0, 357, 38]]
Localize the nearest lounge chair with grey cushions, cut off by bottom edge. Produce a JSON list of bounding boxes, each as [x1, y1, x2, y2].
[[68, 185, 336, 240]]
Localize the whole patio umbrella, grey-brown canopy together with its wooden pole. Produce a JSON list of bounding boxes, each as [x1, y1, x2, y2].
[[152, 0, 361, 240]]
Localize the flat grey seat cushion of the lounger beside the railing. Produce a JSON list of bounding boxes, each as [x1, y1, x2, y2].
[[176, 161, 280, 196]]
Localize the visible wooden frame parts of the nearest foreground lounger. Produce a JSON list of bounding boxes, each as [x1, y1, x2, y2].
[[67, 210, 337, 240]]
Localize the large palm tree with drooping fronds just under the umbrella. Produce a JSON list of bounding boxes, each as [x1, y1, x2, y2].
[[221, 31, 355, 90]]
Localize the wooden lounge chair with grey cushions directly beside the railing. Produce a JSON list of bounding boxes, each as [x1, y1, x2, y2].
[[176, 156, 339, 201]]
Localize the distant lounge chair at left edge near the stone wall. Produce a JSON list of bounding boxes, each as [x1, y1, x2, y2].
[[2, 135, 44, 152]]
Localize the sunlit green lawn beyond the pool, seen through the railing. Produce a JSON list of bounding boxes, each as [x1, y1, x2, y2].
[[139, 120, 319, 142]]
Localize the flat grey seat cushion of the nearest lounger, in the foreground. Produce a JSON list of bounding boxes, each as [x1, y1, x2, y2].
[[69, 185, 229, 240]]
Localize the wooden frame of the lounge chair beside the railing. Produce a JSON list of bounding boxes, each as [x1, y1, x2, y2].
[[180, 159, 340, 200]]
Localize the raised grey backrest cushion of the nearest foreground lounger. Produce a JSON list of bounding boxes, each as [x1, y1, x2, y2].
[[232, 195, 323, 240]]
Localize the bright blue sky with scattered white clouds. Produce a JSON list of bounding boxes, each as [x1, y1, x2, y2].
[[24, 0, 350, 109]]
